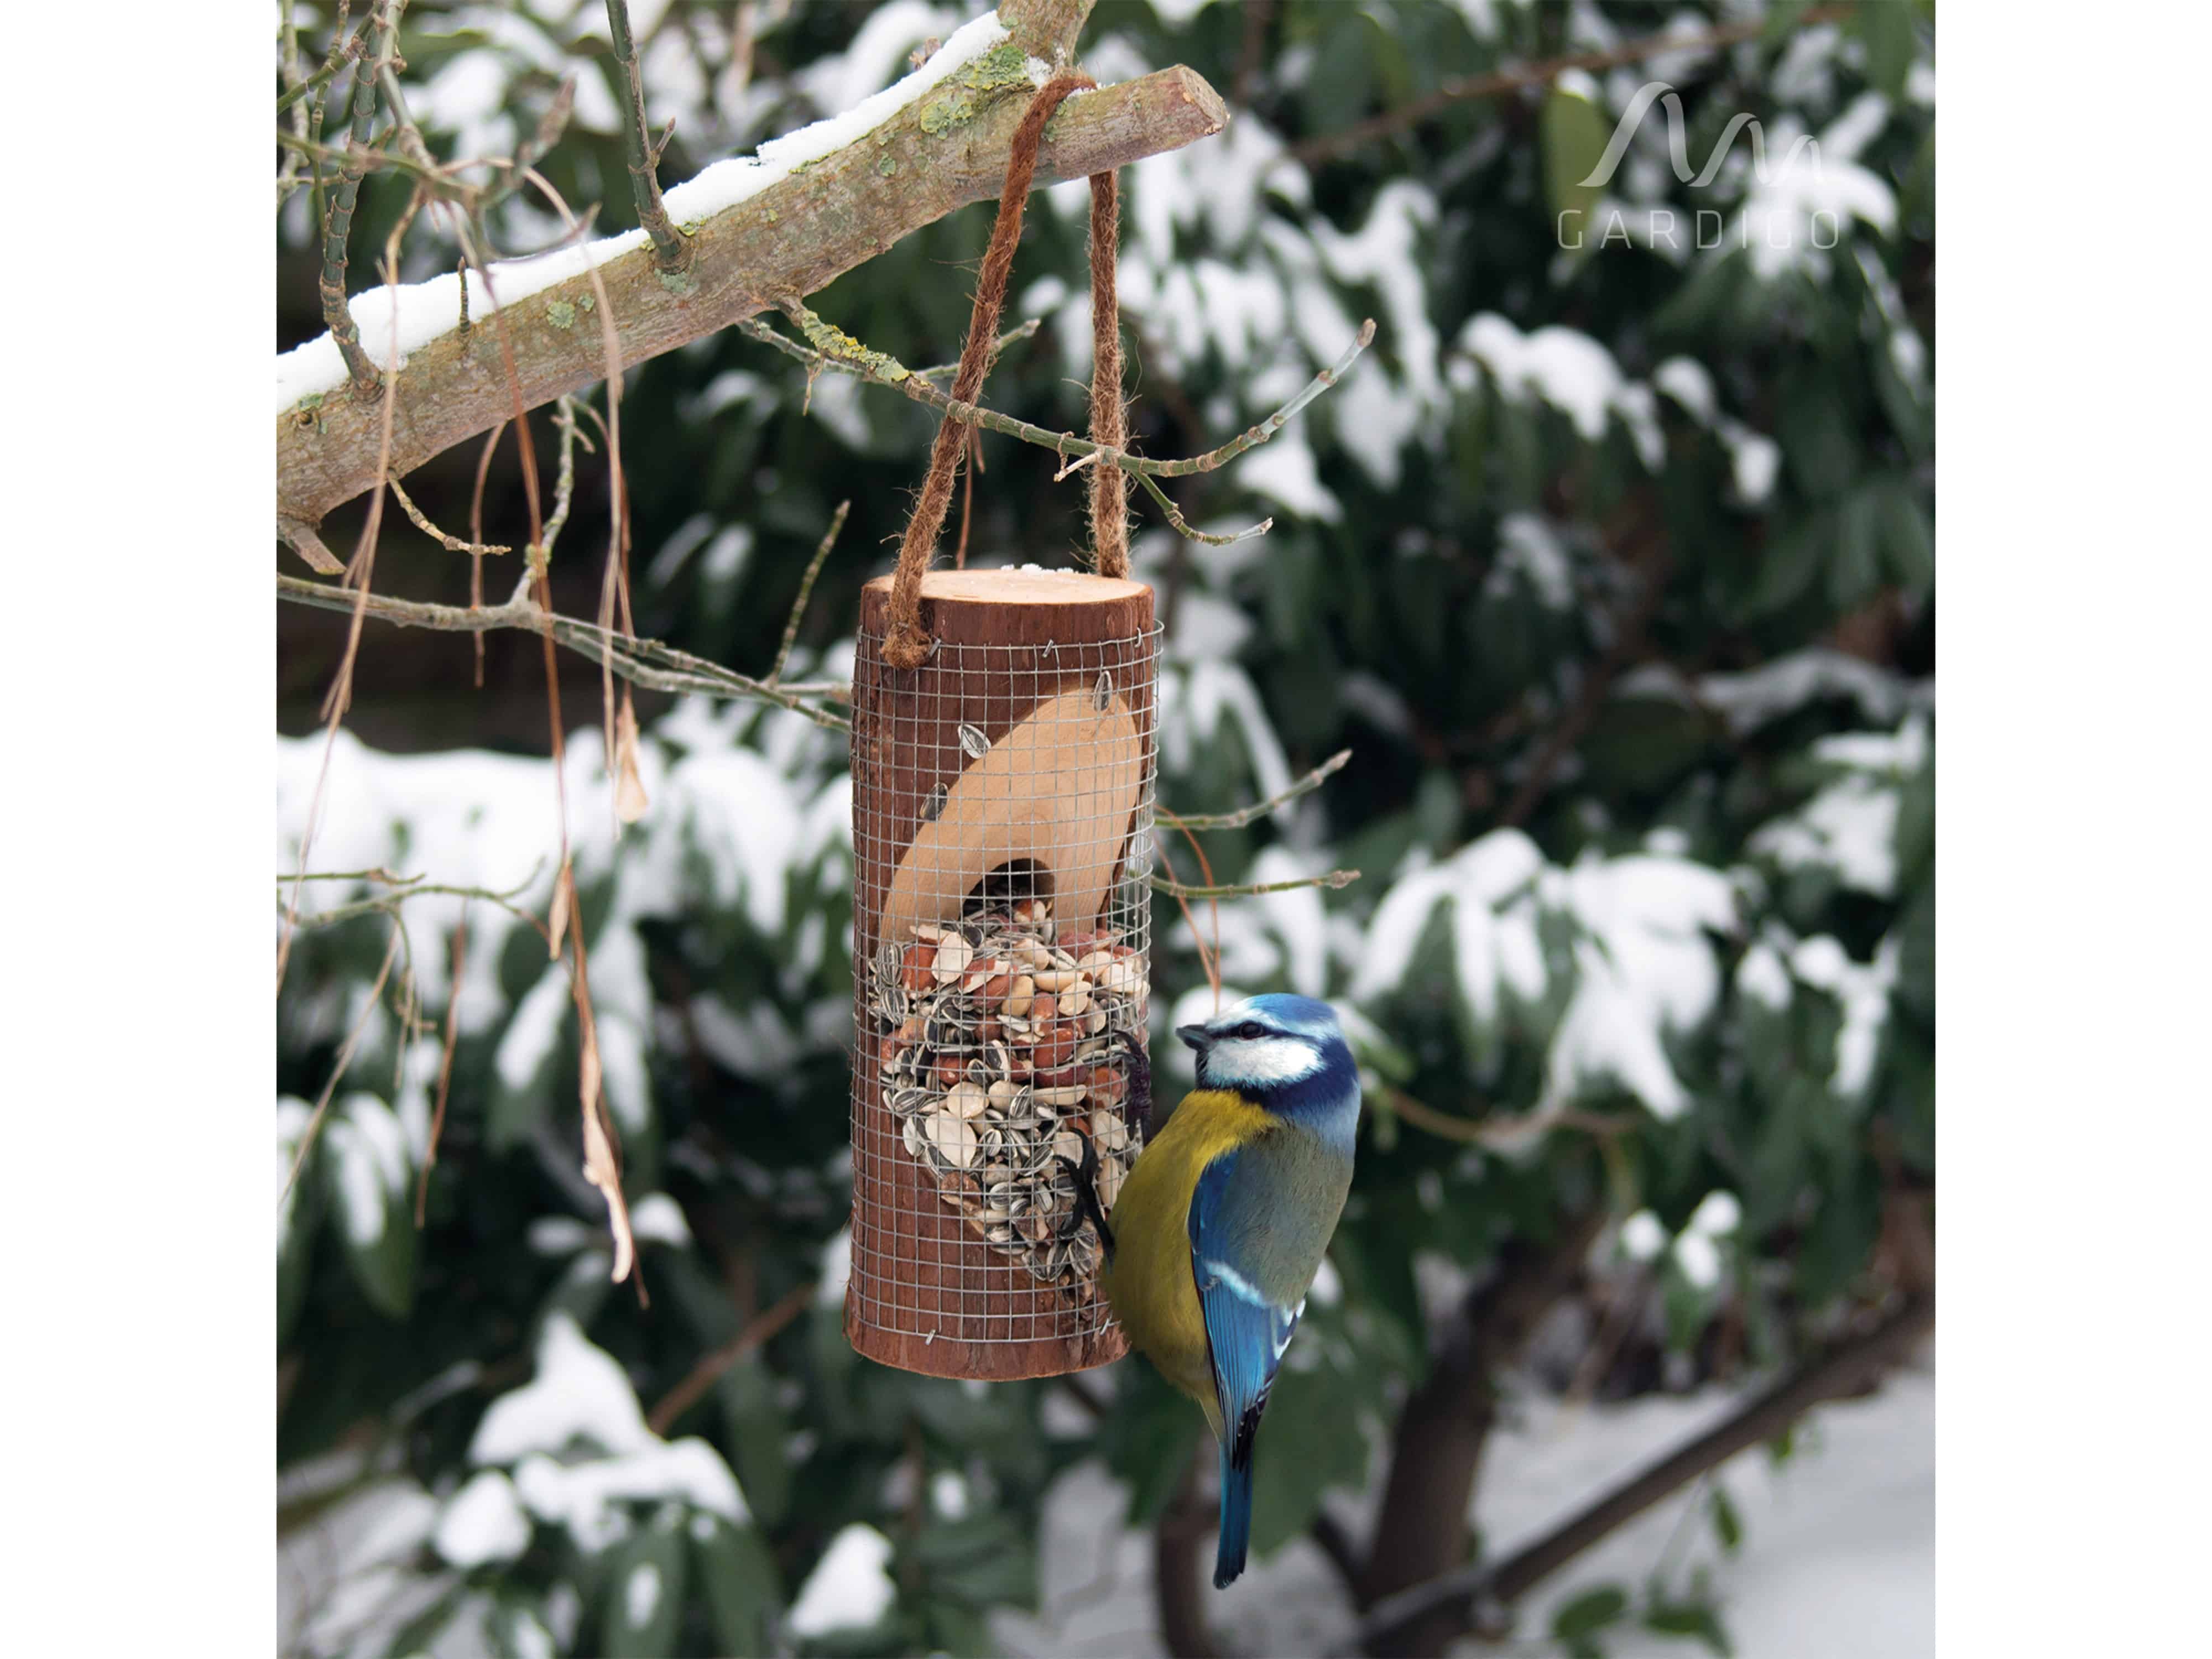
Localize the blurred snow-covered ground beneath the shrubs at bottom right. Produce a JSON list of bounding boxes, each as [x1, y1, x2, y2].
[[991, 1363, 1936, 1659]]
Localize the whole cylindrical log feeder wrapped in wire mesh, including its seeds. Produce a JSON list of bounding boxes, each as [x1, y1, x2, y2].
[[845, 568, 1159, 1378]]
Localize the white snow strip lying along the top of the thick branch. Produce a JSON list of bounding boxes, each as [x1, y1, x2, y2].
[[276, 7, 1009, 416]]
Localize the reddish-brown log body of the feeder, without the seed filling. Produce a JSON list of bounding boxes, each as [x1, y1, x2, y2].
[[845, 571, 1157, 1380]]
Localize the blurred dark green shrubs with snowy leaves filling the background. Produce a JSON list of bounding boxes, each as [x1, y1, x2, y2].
[[274, 0, 1936, 1659]]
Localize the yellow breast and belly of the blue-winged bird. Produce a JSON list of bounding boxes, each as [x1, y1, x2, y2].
[[1104, 1088, 1272, 1436]]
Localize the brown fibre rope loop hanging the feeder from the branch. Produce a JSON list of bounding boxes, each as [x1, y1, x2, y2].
[[883, 75, 1128, 668]]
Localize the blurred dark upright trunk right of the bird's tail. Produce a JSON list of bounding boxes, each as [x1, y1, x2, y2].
[[1360, 1206, 1606, 1655]]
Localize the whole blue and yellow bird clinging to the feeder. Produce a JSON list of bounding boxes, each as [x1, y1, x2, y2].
[[1084, 995, 1360, 1588]]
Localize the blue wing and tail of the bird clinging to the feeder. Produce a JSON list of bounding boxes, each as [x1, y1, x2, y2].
[[1190, 1152, 1305, 1588]]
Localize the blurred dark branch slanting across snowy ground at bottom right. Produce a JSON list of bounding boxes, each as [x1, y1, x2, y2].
[[1358, 1294, 1936, 1652]]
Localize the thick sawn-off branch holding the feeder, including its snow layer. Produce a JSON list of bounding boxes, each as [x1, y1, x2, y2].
[[276, 0, 1228, 526]]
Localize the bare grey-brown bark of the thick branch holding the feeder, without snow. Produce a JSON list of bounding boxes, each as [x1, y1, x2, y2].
[[276, 0, 1228, 526]]
